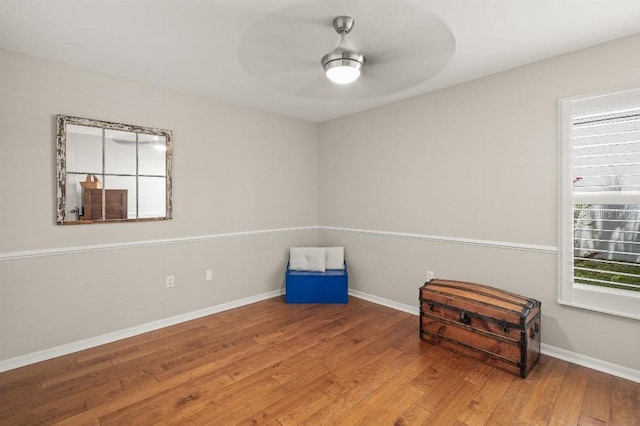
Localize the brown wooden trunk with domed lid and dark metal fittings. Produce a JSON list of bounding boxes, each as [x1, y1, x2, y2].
[[420, 279, 541, 378]]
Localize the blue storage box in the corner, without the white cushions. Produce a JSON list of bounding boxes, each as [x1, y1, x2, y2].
[[285, 262, 349, 303]]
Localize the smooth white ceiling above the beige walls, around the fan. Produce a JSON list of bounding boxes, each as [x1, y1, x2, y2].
[[0, 0, 640, 122]]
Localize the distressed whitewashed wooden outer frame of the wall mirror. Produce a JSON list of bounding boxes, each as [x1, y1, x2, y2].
[[56, 114, 173, 225]]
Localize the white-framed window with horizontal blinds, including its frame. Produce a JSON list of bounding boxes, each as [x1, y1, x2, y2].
[[558, 89, 640, 319]]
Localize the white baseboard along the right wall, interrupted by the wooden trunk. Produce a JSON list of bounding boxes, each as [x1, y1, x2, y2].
[[349, 290, 640, 383]]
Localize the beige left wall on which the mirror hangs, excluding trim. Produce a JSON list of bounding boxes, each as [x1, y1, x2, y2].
[[0, 50, 317, 361]]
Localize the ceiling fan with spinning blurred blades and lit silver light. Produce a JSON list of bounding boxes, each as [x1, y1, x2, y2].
[[238, 0, 455, 100]]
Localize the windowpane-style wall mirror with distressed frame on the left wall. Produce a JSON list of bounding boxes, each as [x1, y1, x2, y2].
[[57, 115, 173, 225]]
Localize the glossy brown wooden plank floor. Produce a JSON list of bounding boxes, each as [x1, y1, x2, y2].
[[0, 298, 640, 425]]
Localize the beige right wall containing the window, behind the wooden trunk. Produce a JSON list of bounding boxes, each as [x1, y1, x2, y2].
[[318, 35, 640, 370]]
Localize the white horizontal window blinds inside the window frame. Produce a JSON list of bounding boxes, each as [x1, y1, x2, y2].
[[572, 106, 640, 291]]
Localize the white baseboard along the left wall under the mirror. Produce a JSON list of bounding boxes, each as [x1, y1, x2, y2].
[[0, 289, 283, 372]]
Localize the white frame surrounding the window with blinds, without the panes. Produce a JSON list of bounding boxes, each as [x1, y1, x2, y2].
[[558, 87, 640, 320]]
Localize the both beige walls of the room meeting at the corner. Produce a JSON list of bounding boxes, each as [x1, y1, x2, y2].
[[0, 36, 640, 370]]
